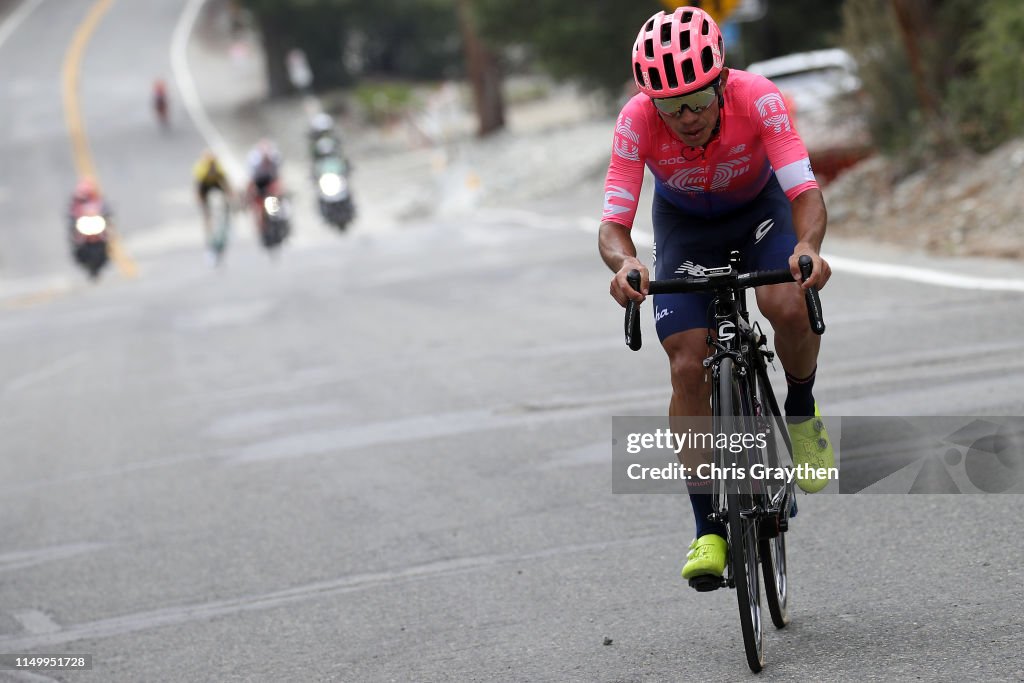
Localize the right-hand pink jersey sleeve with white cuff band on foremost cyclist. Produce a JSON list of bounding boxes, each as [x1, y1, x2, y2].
[[750, 77, 818, 201]]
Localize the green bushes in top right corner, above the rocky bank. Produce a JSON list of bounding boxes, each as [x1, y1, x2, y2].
[[842, 0, 1024, 156]]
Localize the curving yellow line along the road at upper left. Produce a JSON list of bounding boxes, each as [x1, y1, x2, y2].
[[61, 0, 138, 278]]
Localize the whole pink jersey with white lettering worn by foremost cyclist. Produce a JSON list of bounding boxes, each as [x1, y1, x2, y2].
[[602, 69, 818, 227]]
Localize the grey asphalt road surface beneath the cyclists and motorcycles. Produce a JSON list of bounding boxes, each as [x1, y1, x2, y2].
[[0, 0, 1024, 681]]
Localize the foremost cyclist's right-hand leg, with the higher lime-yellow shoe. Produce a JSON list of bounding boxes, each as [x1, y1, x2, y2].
[[745, 179, 835, 493]]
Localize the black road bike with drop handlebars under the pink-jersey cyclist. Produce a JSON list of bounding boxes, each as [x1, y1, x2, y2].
[[626, 251, 825, 673]]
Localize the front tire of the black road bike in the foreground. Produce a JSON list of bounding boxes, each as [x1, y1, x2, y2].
[[717, 358, 764, 674]]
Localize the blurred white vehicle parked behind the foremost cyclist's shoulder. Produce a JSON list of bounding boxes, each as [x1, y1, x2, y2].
[[744, 48, 871, 179]]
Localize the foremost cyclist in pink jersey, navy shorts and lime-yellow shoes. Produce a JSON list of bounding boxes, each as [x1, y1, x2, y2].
[[599, 7, 835, 579]]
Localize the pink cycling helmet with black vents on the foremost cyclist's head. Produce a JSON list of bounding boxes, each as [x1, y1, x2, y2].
[[633, 7, 725, 97]]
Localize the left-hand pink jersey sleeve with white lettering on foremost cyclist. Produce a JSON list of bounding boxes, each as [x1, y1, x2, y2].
[[601, 97, 650, 227]]
